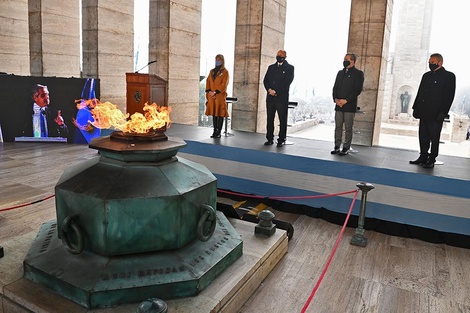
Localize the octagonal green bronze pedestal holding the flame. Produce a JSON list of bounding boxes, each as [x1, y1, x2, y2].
[[24, 137, 243, 308]]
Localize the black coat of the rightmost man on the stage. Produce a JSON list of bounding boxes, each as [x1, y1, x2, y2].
[[413, 67, 455, 122]]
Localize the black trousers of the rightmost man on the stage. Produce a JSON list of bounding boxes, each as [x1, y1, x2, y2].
[[419, 120, 443, 162]]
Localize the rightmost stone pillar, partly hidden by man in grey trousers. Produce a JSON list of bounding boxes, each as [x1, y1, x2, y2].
[[348, 0, 393, 146]]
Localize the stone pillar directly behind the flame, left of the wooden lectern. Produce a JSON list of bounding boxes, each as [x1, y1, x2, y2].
[[82, 0, 134, 112]]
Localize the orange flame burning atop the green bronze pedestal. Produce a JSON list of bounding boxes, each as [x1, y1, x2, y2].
[[77, 99, 171, 134]]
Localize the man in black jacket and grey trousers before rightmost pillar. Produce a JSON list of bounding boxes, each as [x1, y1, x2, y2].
[[331, 53, 364, 155]]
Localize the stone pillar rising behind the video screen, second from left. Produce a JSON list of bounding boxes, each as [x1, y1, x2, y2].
[[28, 0, 80, 77]]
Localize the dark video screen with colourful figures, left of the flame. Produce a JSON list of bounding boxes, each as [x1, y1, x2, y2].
[[0, 74, 100, 144]]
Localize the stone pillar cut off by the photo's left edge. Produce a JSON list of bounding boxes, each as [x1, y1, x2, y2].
[[0, 0, 30, 75]]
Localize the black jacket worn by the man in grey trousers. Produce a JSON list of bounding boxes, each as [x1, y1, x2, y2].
[[333, 66, 364, 112]]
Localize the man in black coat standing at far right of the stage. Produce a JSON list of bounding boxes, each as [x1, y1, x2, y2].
[[410, 53, 455, 168]]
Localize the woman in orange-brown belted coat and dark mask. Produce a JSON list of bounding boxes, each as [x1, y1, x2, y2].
[[205, 54, 229, 138]]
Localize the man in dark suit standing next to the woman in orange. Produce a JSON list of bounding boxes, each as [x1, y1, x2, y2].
[[263, 50, 294, 147]]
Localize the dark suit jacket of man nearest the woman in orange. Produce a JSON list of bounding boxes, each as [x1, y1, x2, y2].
[[263, 60, 294, 105]]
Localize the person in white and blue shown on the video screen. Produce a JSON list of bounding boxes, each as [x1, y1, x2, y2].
[[32, 84, 68, 138]]
